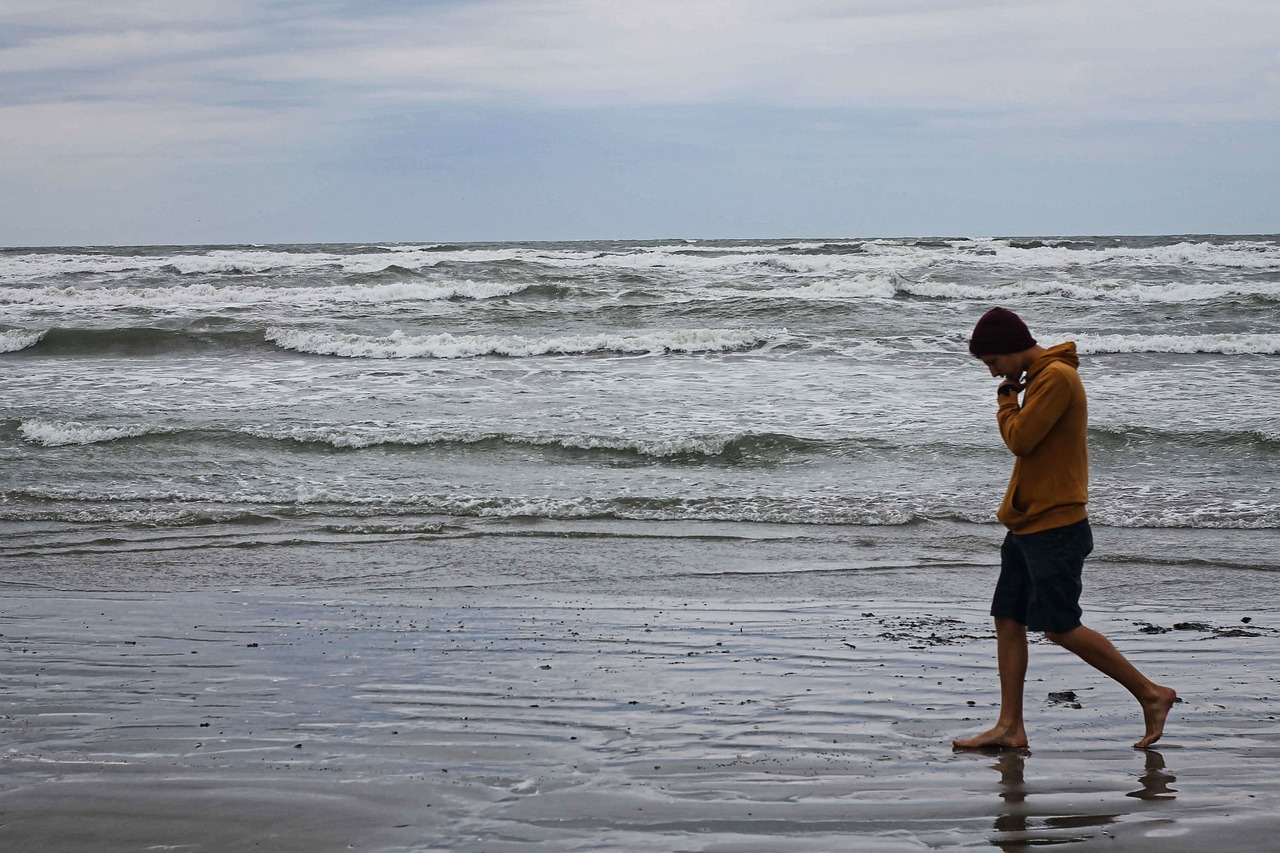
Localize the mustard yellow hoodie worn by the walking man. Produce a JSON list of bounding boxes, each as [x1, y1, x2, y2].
[[996, 343, 1089, 534]]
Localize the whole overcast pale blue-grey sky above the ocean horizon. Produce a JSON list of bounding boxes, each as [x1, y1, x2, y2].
[[0, 0, 1280, 246]]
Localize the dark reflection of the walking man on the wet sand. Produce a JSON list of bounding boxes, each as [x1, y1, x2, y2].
[[991, 749, 1176, 853]]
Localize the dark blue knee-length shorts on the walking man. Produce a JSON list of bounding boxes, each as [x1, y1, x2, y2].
[[991, 519, 1093, 634]]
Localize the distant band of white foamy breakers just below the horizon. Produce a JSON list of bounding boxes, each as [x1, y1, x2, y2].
[[0, 238, 1280, 313]]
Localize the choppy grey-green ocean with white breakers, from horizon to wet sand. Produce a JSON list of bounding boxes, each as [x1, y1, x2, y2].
[[0, 236, 1280, 601]]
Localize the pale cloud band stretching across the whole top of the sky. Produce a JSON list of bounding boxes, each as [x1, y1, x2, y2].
[[0, 0, 1280, 120]]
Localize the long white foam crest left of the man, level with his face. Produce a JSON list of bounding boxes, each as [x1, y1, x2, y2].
[[266, 328, 787, 359]]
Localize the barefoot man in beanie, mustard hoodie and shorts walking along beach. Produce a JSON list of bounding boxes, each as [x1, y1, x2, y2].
[[954, 307, 1178, 749]]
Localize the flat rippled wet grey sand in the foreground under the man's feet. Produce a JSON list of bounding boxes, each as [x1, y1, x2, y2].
[[0, 587, 1280, 853]]
